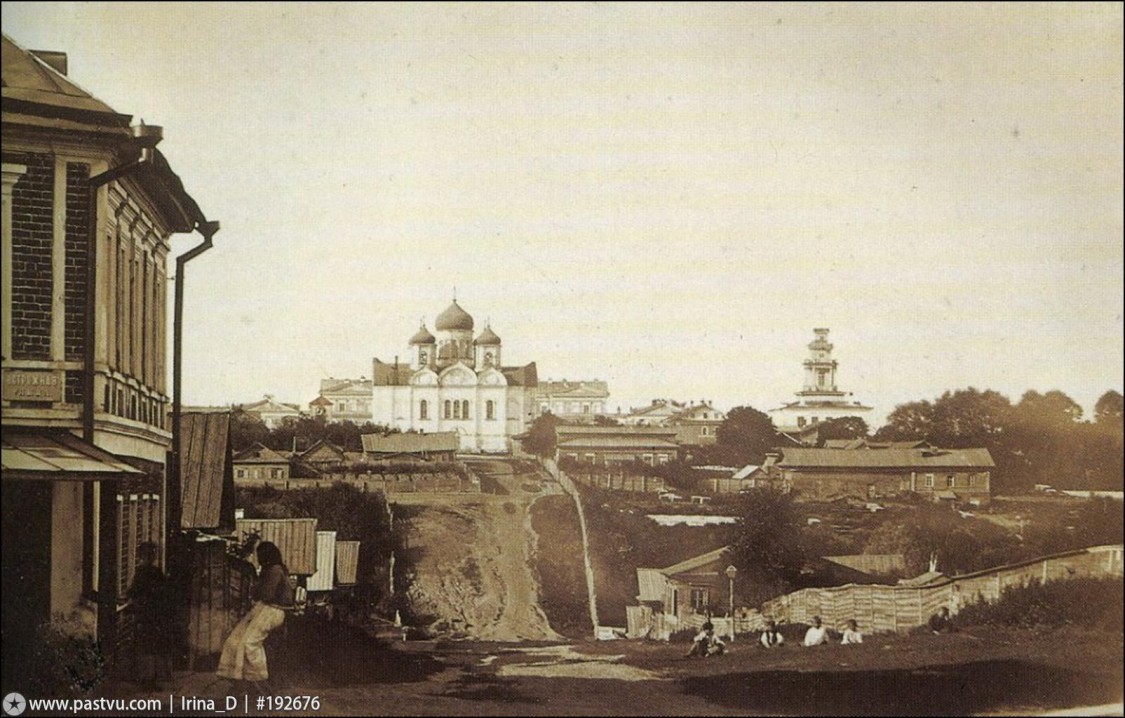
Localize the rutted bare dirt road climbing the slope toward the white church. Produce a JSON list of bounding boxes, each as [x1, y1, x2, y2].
[[408, 460, 563, 641]]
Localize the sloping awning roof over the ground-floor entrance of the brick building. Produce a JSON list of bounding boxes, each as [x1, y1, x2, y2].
[[0, 430, 144, 481]]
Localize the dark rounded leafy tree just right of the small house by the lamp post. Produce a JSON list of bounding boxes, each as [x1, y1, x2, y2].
[[729, 488, 804, 600]]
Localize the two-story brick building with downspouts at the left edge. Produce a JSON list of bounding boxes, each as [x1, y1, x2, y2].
[[0, 36, 206, 670]]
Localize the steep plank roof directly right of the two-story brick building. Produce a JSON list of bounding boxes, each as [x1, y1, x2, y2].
[[180, 413, 234, 529]]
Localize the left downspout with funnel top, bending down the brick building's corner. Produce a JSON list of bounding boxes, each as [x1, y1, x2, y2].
[[82, 123, 164, 443]]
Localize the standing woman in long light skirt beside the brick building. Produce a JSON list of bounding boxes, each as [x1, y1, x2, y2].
[[215, 541, 294, 683]]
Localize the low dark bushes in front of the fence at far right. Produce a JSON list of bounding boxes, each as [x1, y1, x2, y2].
[[956, 578, 1123, 634]]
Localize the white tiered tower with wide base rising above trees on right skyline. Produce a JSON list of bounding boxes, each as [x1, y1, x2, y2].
[[768, 329, 872, 441]]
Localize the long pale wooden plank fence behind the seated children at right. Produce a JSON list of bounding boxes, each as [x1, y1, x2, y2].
[[753, 546, 1122, 632]]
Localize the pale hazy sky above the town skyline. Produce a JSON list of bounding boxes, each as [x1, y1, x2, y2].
[[2, 2, 1123, 425]]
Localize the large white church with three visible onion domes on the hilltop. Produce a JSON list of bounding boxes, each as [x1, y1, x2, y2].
[[371, 299, 539, 452]]
